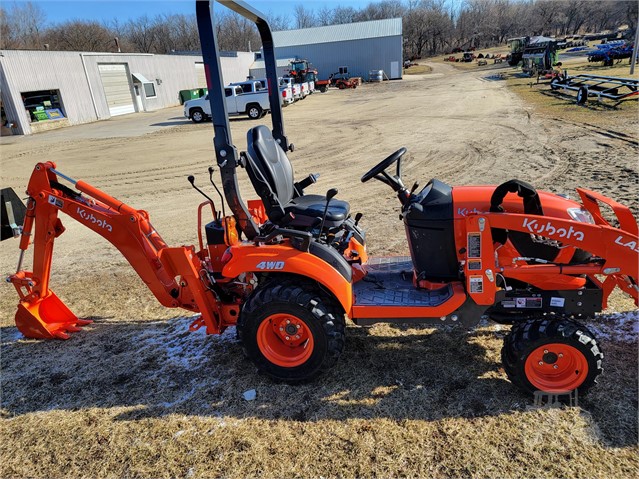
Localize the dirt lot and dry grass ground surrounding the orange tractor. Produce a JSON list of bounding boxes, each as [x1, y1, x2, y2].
[[0, 62, 639, 478]]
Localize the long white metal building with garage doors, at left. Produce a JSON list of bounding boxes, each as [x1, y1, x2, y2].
[[0, 50, 254, 135]]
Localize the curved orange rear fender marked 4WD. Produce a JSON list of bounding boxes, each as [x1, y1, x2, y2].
[[222, 243, 353, 317]]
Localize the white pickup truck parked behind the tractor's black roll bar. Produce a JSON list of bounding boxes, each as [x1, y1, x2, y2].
[[184, 82, 270, 123]]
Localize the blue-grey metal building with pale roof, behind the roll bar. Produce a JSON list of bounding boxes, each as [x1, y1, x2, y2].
[[251, 18, 403, 80]]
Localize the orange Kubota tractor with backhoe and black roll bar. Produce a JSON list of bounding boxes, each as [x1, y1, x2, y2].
[[3, 0, 639, 393]]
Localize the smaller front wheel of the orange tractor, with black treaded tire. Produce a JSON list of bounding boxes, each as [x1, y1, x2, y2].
[[501, 319, 603, 396]]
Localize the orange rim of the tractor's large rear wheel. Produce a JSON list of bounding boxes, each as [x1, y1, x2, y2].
[[257, 313, 314, 368]]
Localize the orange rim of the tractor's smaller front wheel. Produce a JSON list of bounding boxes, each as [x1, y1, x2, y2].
[[525, 343, 588, 393]]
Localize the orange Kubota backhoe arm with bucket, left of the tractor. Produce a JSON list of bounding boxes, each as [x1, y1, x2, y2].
[[8, 162, 225, 339]]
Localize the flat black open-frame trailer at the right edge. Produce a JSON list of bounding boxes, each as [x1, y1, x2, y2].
[[550, 75, 639, 105]]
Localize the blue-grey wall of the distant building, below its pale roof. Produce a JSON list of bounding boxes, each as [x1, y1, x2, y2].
[[275, 35, 403, 80]]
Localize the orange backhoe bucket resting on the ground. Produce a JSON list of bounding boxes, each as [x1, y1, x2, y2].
[[16, 291, 92, 339]]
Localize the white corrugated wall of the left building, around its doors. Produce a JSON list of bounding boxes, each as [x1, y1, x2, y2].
[[0, 50, 254, 134]]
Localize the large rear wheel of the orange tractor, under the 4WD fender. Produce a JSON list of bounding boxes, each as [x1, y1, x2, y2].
[[237, 280, 345, 382]]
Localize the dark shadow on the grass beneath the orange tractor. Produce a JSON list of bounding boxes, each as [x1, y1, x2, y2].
[[1, 317, 637, 447]]
